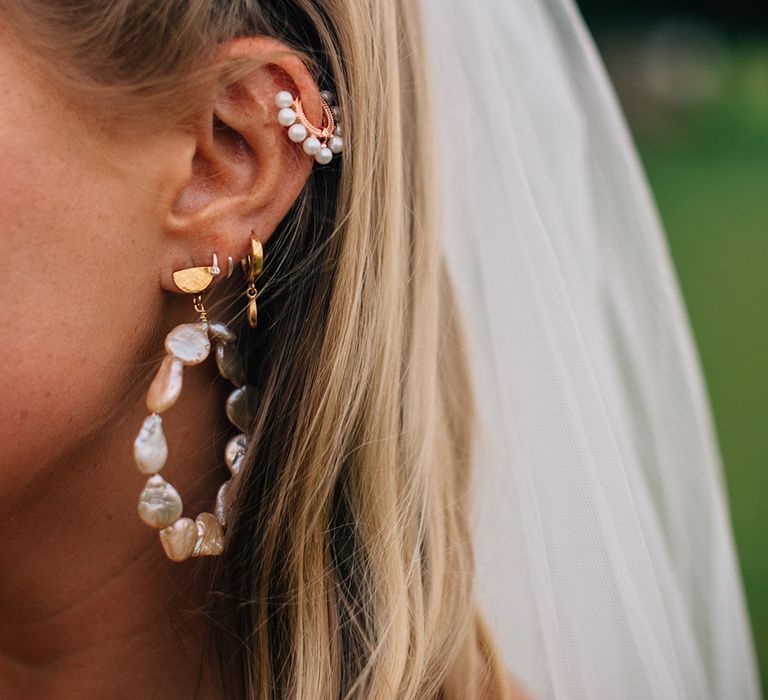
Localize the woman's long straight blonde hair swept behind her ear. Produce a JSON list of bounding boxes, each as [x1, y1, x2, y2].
[[11, 0, 504, 700]]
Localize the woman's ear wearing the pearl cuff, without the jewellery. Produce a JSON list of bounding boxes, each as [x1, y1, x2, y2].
[[161, 37, 322, 291]]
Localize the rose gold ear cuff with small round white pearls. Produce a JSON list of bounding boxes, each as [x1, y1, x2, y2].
[[275, 90, 344, 165]]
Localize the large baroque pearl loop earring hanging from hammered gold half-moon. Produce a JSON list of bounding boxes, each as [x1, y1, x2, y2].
[[134, 253, 252, 561]]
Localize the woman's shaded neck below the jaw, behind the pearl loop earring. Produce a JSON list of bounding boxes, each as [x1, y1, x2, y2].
[[0, 316, 226, 698]]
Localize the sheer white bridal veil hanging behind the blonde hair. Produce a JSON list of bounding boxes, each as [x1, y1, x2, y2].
[[422, 0, 759, 700]]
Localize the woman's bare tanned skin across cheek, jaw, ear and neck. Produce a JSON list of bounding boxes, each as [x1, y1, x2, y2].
[[0, 26, 320, 698]]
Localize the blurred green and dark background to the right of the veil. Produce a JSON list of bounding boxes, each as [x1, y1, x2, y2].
[[579, 0, 768, 700]]
